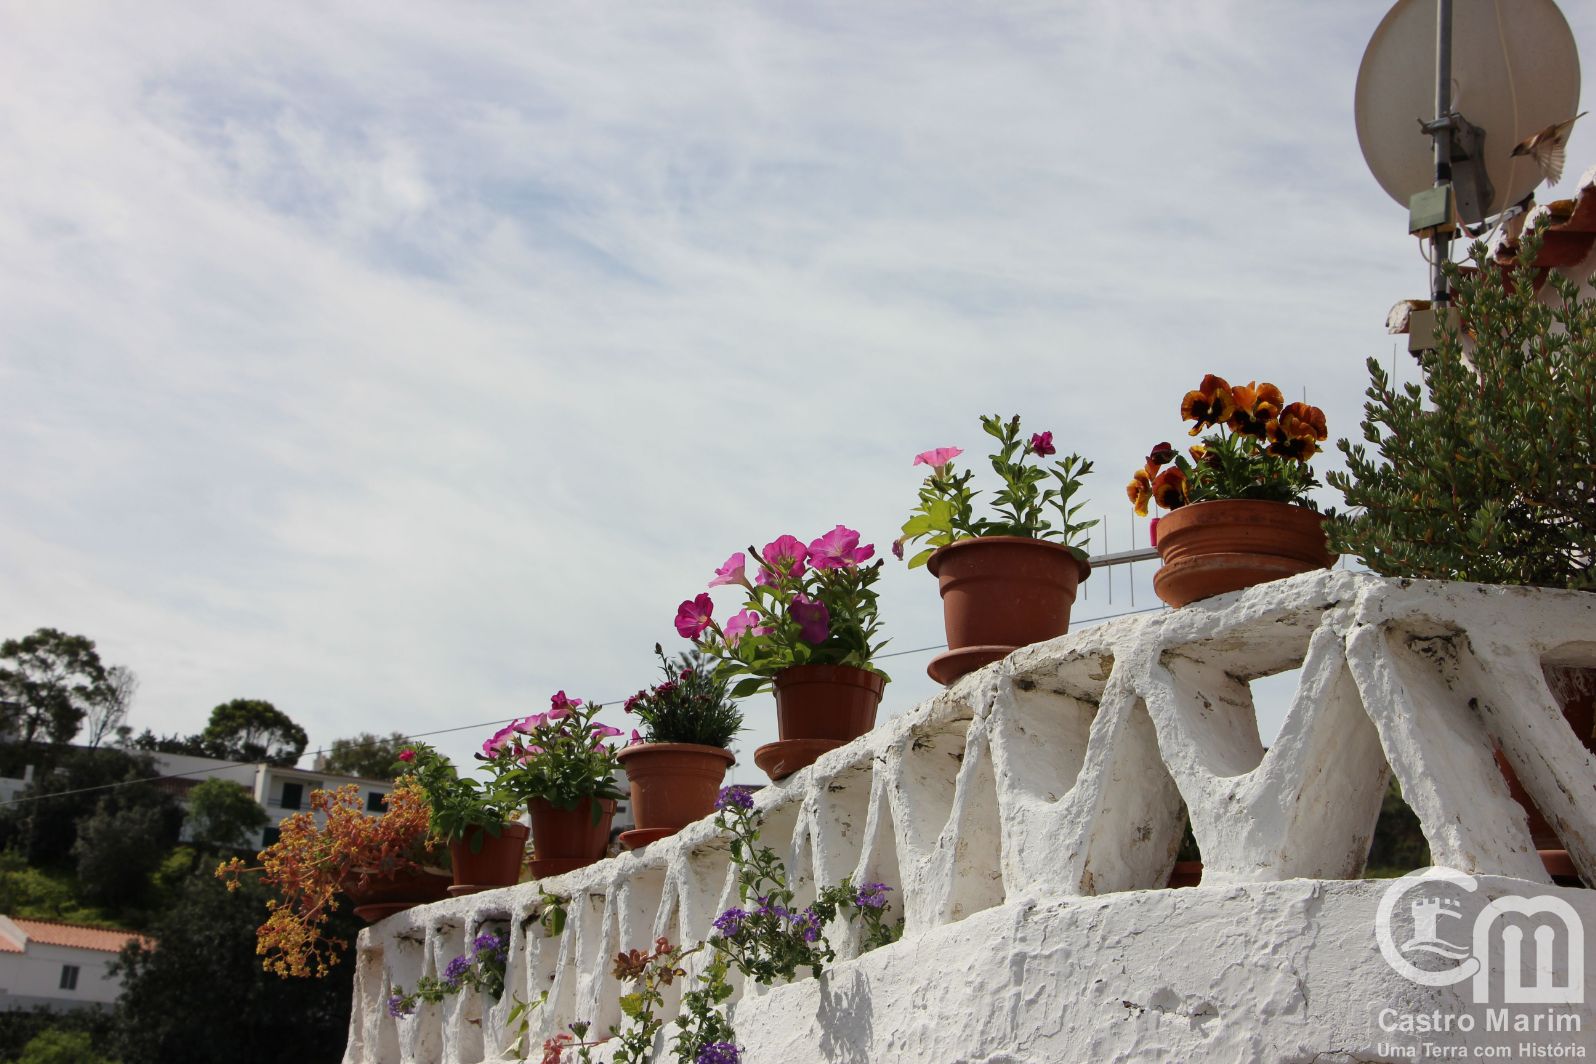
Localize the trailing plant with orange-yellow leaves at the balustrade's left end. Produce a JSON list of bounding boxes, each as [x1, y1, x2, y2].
[[215, 777, 433, 978]]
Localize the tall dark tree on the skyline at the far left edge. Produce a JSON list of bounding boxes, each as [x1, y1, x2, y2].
[[0, 629, 110, 745]]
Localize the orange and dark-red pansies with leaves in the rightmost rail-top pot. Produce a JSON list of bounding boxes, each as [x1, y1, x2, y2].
[[1125, 373, 1328, 517]]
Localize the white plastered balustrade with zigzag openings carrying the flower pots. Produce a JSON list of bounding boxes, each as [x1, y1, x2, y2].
[[345, 571, 1596, 1064]]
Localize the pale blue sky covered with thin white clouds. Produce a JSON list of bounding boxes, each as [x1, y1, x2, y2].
[[0, 0, 1596, 777]]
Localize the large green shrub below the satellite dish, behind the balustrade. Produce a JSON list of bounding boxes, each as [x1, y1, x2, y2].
[[1329, 230, 1596, 590]]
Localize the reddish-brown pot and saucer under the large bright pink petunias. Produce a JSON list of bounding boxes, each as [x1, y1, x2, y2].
[[753, 665, 886, 780]]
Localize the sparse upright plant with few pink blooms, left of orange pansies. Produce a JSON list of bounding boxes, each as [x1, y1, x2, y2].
[[892, 413, 1096, 569]]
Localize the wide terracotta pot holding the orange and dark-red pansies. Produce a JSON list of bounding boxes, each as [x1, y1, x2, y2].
[[1152, 499, 1337, 606]]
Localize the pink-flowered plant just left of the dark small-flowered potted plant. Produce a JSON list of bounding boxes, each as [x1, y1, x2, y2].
[[477, 691, 622, 823]]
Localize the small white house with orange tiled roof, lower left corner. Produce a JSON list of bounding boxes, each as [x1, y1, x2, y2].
[[0, 916, 152, 1010]]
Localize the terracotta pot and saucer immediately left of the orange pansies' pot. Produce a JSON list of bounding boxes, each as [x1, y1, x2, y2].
[[926, 536, 1092, 684]]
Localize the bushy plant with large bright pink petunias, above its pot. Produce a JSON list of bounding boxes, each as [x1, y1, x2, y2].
[[677, 525, 886, 699]]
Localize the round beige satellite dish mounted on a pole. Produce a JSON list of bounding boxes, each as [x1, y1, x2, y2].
[[1353, 0, 1580, 215]]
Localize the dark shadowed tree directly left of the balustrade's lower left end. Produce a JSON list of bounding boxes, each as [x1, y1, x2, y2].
[[115, 873, 359, 1064]]
